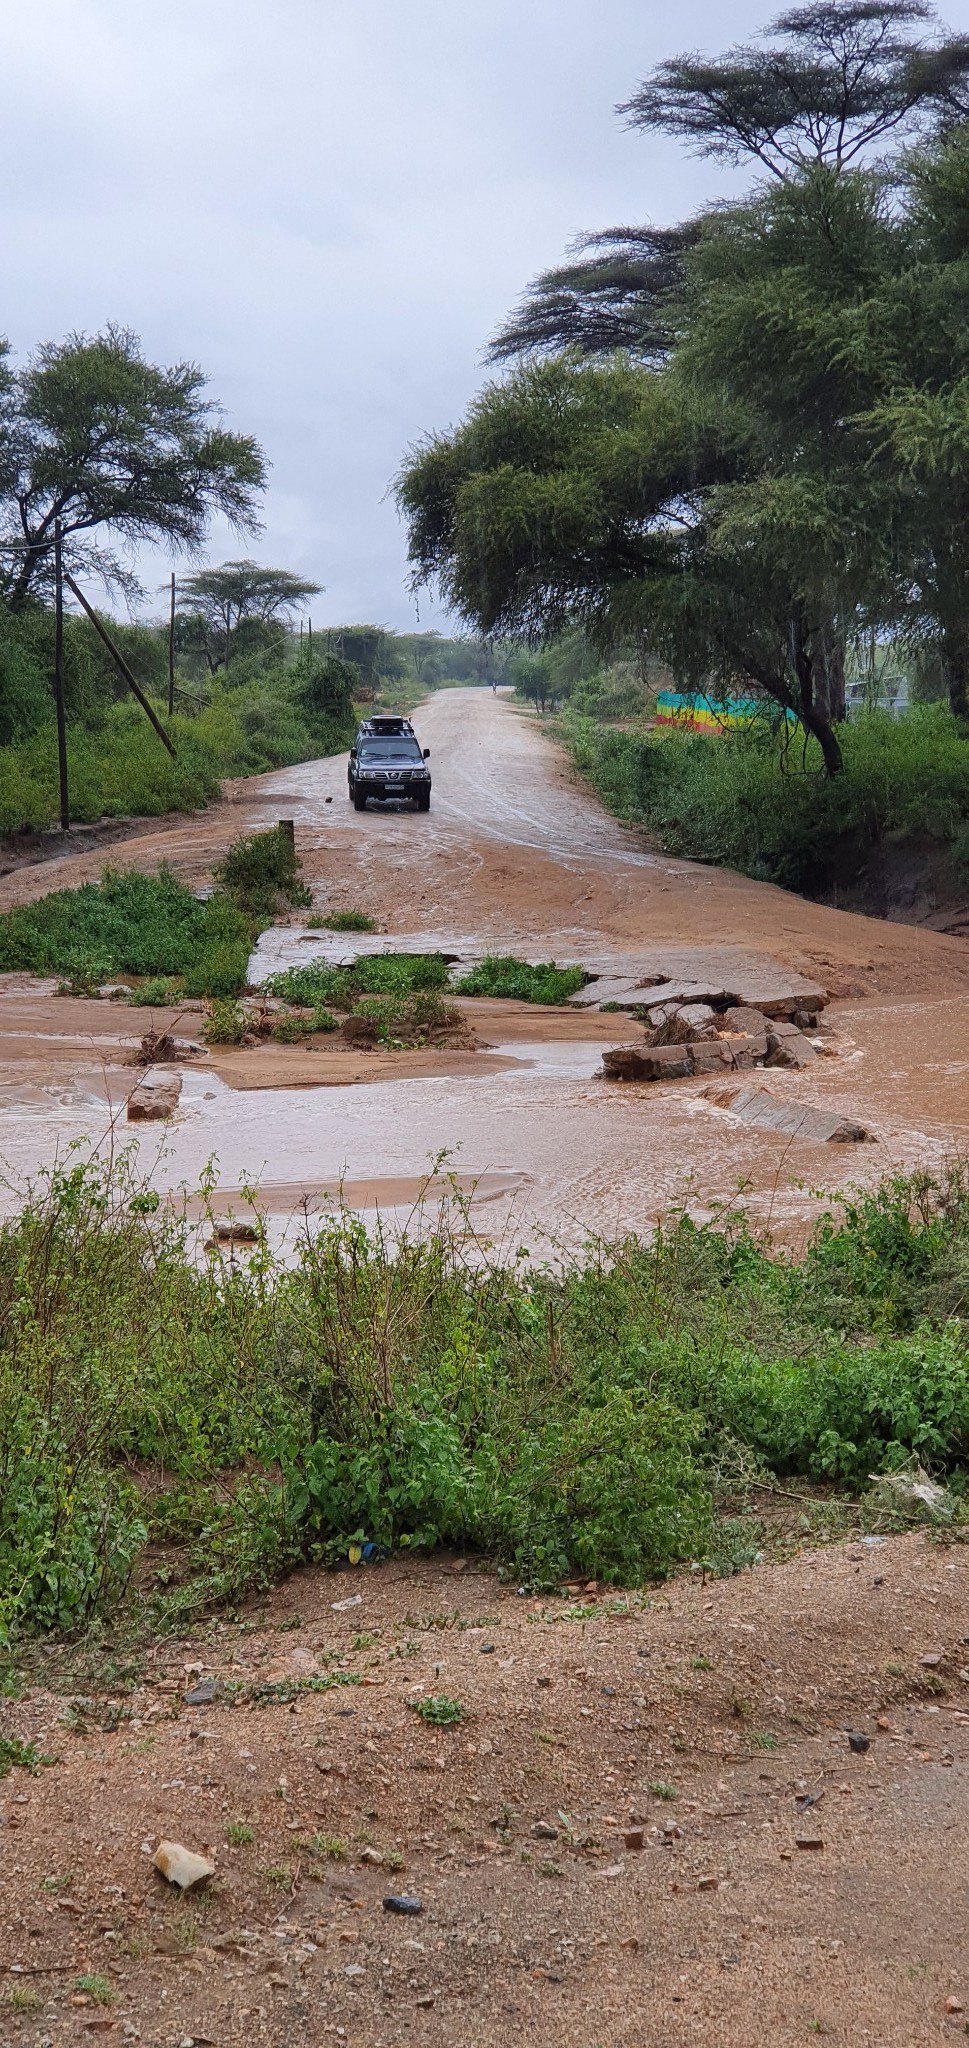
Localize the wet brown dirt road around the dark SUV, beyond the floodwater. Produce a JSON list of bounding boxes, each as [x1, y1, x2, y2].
[[0, 690, 969, 995]]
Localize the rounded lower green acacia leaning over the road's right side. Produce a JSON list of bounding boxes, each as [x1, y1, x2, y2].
[[397, 348, 864, 774]]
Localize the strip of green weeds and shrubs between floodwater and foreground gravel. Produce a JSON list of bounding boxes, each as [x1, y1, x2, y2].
[[0, 1159, 969, 1632]]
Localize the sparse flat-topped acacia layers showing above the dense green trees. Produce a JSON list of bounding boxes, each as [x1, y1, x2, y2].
[[490, 0, 969, 362]]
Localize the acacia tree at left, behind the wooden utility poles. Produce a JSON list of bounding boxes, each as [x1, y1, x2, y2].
[[0, 326, 266, 608]]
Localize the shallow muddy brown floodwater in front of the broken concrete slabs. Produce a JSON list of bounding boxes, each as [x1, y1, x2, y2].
[[0, 983, 969, 1257]]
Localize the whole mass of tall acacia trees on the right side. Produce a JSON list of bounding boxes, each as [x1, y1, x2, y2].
[[397, 0, 969, 772]]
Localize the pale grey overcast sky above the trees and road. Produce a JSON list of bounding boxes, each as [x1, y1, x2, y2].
[[0, 0, 954, 629]]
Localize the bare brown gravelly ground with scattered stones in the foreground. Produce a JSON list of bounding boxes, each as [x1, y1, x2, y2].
[[0, 1534, 969, 2048]]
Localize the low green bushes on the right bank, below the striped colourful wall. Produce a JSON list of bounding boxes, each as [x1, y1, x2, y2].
[[561, 705, 969, 924]]
